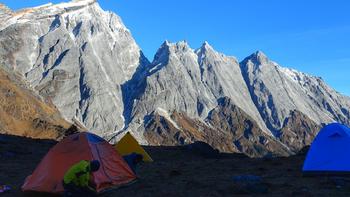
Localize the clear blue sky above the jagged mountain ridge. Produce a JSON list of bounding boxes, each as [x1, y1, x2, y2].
[[0, 0, 350, 96]]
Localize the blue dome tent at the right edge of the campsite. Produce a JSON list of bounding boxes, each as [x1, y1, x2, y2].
[[303, 123, 350, 173]]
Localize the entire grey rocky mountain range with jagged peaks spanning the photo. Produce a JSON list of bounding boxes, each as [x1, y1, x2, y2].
[[0, 0, 350, 157]]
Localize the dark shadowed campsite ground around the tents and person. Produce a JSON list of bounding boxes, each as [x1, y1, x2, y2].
[[0, 135, 350, 197]]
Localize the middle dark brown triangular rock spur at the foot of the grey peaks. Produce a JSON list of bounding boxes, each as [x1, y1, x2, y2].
[[206, 97, 291, 157]]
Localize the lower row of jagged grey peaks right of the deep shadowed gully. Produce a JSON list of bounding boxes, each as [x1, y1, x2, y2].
[[129, 42, 350, 157]]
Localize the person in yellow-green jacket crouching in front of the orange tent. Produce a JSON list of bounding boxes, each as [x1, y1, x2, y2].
[[63, 160, 100, 197]]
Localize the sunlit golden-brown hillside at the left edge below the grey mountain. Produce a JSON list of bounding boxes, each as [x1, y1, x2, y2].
[[0, 68, 70, 139]]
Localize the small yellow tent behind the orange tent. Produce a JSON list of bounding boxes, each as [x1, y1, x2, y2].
[[114, 132, 153, 162]]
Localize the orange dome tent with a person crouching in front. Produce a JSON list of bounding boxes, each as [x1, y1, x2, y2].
[[22, 132, 136, 193]]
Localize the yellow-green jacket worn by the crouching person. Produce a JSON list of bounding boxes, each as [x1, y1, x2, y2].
[[63, 160, 90, 187]]
